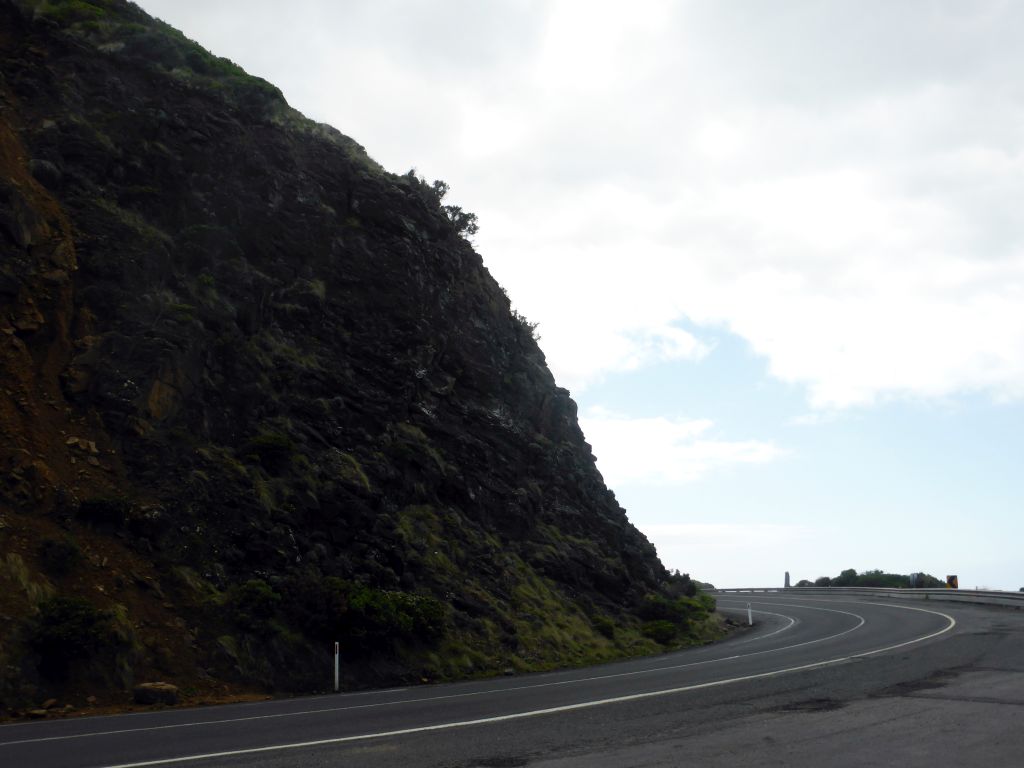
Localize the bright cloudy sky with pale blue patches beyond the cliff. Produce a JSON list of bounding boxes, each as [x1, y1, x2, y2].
[[140, 0, 1024, 589]]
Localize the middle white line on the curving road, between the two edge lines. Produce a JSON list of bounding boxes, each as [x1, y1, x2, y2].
[[0, 603, 847, 749]]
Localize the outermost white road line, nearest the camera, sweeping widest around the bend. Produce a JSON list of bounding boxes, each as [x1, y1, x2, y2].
[[92, 603, 956, 768]]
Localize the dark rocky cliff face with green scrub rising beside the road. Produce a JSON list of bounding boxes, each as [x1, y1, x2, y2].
[[0, 0, 688, 708]]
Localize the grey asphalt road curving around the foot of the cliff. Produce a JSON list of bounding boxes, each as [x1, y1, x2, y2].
[[0, 595, 1024, 768]]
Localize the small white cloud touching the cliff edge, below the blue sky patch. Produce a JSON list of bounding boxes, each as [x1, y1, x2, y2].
[[580, 409, 784, 487]]
